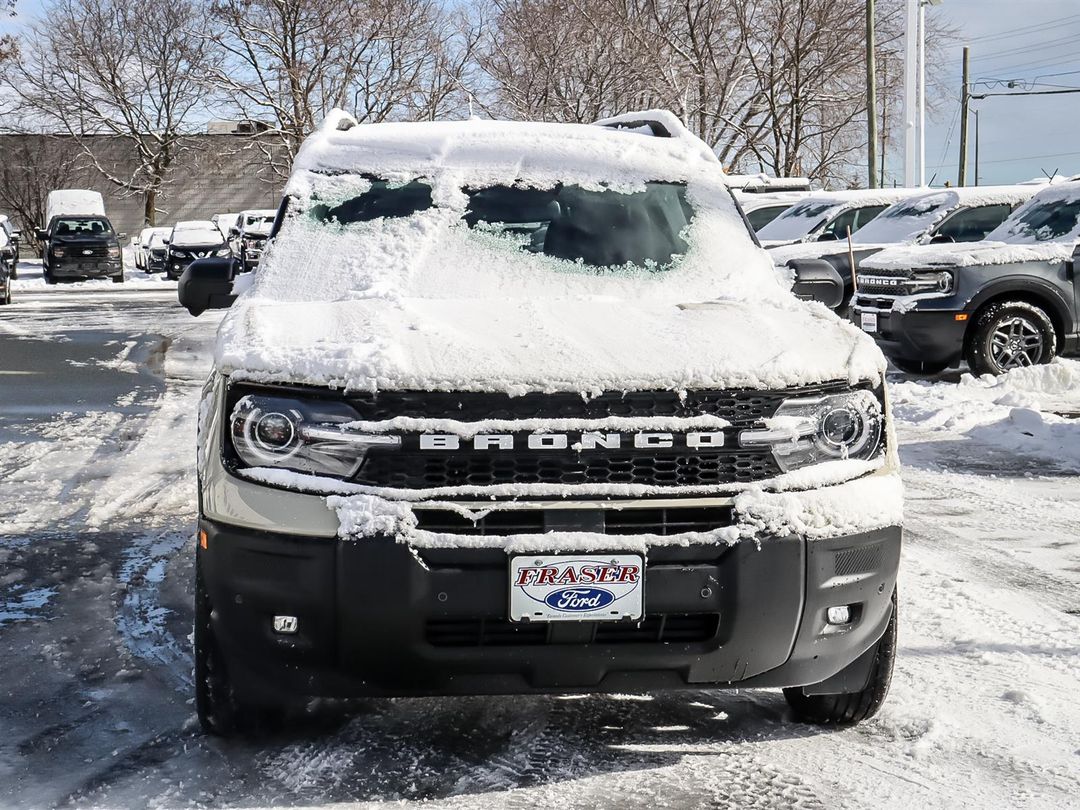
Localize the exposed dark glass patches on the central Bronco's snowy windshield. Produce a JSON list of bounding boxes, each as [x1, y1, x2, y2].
[[310, 180, 693, 270]]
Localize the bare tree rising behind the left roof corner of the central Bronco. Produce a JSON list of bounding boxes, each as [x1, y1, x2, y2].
[[210, 0, 476, 175]]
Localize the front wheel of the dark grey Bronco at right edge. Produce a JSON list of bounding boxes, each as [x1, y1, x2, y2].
[[967, 301, 1057, 375]]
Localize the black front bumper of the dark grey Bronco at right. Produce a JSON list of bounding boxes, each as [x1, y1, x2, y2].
[[852, 299, 969, 366]]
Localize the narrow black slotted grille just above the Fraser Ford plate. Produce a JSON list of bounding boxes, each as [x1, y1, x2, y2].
[[416, 504, 732, 536]]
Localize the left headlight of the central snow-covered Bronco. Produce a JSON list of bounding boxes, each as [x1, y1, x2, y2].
[[229, 394, 401, 478]]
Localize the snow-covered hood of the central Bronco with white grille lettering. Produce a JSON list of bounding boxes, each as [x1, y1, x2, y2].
[[216, 298, 885, 394]]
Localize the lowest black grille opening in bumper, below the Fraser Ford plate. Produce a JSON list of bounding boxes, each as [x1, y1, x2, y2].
[[424, 613, 720, 647]]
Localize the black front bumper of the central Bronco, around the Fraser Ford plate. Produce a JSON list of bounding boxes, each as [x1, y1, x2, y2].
[[199, 521, 901, 701]]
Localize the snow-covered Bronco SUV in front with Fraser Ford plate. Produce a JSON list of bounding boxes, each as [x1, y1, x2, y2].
[[179, 112, 902, 733]]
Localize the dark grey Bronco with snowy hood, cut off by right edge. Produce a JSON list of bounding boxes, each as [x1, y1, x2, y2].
[[854, 181, 1080, 374]]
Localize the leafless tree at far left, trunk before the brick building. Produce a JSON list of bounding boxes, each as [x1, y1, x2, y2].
[[3, 0, 215, 224]]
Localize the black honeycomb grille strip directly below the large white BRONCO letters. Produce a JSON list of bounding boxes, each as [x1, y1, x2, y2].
[[354, 449, 780, 489]]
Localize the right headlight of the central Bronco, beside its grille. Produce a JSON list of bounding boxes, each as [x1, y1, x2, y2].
[[739, 391, 885, 472]]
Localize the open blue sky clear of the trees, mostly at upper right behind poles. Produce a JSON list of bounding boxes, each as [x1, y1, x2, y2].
[[0, 0, 1080, 185]]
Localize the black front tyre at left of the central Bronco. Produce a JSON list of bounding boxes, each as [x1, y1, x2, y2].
[[193, 563, 282, 737]]
